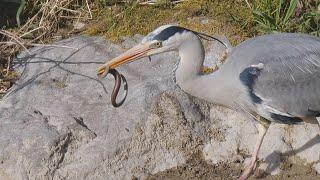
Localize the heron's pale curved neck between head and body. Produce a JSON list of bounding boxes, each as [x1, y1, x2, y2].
[[176, 37, 224, 105]]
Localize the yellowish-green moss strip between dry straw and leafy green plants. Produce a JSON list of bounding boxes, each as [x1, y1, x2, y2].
[[86, 0, 253, 44]]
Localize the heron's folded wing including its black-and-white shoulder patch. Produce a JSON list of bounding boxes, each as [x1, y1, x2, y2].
[[240, 34, 320, 123]]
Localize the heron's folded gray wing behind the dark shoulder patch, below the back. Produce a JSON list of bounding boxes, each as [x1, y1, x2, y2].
[[249, 47, 320, 117]]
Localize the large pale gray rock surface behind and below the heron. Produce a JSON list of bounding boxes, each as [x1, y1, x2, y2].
[[0, 36, 320, 179]]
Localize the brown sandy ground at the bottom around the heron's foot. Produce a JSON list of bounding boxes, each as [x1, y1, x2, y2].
[[148, 153, 320, 180]]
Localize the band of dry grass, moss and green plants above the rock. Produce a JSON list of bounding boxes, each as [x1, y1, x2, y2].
[[0, 0, 320, 94]]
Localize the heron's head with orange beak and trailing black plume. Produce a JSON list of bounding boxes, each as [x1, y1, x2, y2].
[[98, 25, 223, 78]]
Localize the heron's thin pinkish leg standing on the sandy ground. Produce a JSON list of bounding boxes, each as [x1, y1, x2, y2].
[[239, 119, 270, 180]]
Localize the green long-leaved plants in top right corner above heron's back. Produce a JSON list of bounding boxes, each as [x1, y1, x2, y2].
[[252, 0, 320, 36]]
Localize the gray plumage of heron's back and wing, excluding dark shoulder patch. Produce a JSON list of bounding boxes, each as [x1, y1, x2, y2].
[[232, 34, 320, 117]]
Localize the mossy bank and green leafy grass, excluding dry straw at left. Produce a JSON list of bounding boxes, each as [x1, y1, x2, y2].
[[86, 0, 320, 45]]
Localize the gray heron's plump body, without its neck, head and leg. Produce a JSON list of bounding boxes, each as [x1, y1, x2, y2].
[[185, 33, 320, 124]]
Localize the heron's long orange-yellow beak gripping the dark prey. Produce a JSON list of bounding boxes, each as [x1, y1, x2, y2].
[[97, 43, 153, 78]]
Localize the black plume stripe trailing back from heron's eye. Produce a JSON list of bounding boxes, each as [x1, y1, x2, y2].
[[153, 26, 227, 48]]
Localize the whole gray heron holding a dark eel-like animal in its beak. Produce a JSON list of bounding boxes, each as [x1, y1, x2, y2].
[[98, 25, 320, 179]]
